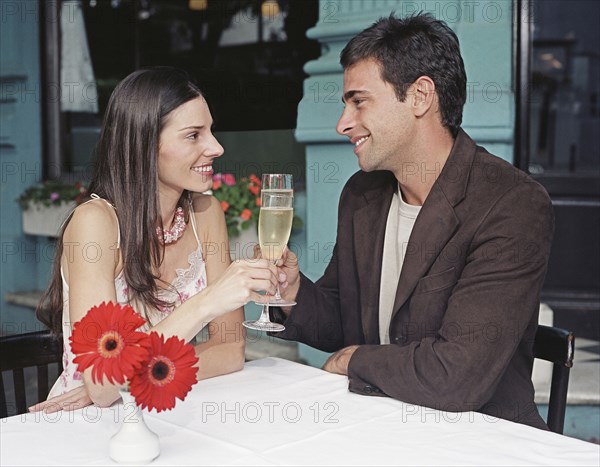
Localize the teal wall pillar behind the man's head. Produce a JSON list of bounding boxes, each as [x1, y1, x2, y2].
[[296, 0, 515, 366]]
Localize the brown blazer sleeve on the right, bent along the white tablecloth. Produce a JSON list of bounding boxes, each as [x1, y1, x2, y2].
[[348, 183, 554, 411]]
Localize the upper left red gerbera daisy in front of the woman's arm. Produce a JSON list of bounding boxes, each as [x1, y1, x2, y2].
[[70, 302, 149, 384]]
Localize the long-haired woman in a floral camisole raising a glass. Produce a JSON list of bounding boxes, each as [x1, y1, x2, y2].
[[30, 67, 276, 412]]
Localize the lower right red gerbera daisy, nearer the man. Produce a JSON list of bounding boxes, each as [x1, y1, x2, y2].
[[129, 332, 198, 412]]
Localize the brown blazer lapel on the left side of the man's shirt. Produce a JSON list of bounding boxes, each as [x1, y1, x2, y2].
[[352, 177, 395, 344]]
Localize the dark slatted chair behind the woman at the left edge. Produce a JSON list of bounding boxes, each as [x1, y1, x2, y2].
[[0, 331, 63, 418]]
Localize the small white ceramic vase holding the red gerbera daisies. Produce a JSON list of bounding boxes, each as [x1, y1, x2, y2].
[[109, 390, 160, 464]]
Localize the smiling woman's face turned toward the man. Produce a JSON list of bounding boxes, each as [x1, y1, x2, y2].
[[158, 97, 223, 198]]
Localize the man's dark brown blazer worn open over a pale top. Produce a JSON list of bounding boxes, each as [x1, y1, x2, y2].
[[273, 130, 554, 428]]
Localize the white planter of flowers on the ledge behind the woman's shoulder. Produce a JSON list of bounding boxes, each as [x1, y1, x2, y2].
[[17, 180, 86, 237]]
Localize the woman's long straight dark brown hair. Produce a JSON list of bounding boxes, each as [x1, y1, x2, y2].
[[36, 67, 202, 334]]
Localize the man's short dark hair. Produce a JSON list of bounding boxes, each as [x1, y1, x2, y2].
[[340, 13, 467, 137]]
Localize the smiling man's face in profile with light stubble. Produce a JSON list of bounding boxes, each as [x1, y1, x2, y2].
[[336, 59, 415, 173]]
